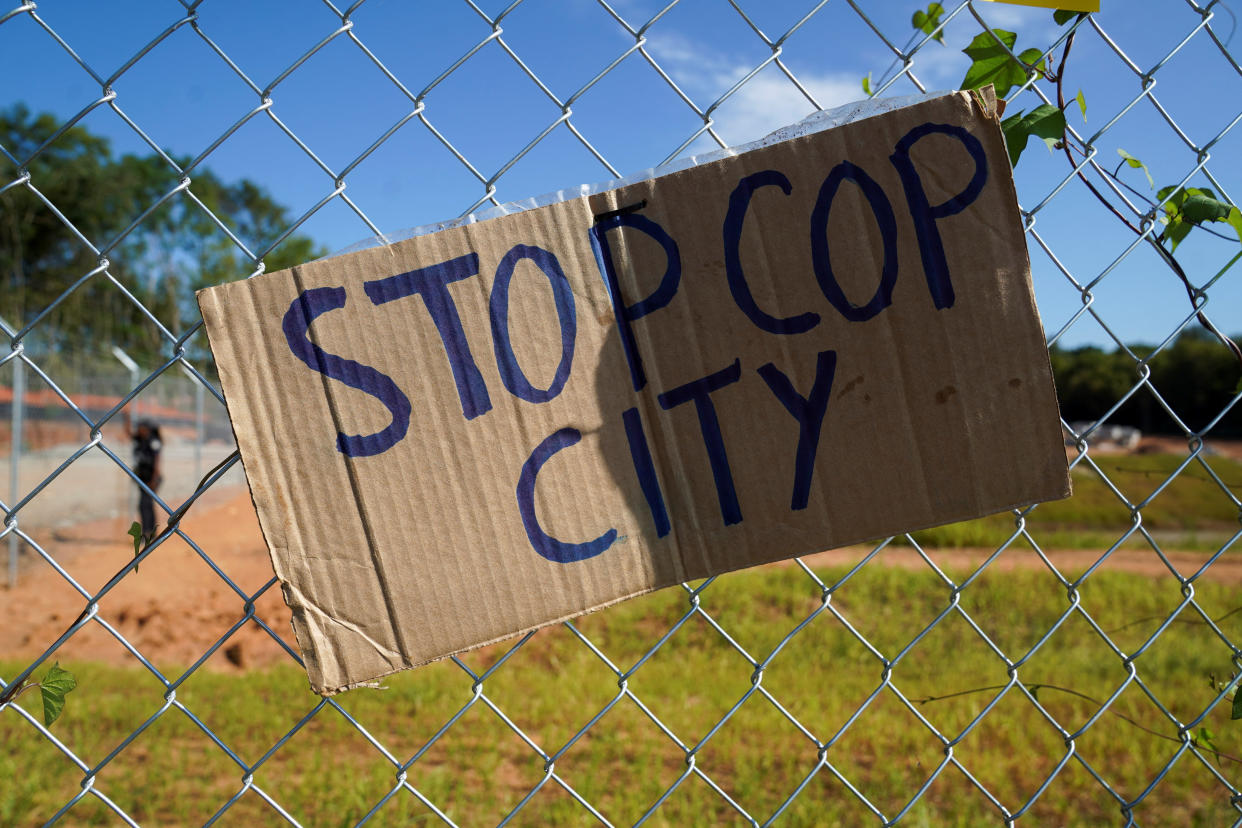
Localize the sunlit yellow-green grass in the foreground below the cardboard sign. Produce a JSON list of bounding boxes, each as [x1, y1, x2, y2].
[[0, 566, 1242, 827]]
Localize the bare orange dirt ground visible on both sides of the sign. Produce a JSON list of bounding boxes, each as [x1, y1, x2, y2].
[[0, 487, 1242, 670]]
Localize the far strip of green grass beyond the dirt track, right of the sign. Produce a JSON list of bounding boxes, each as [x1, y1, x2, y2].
[[913, 454, 1242, 550]]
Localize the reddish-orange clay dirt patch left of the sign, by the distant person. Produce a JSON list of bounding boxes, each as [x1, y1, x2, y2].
[[0, 489, 297, 669]]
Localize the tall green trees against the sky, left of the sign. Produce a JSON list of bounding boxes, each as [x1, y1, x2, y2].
[[0, 104, 325, 370]]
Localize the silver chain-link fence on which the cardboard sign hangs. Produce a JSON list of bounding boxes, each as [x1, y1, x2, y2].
[[0, 0, 1242, 826]]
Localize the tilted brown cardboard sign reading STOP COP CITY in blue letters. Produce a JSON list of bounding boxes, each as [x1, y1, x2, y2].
[[199, 93, 1069, 693]]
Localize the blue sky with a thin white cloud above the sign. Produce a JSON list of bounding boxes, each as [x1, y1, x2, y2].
[[0, 0, 1242, 345]]
